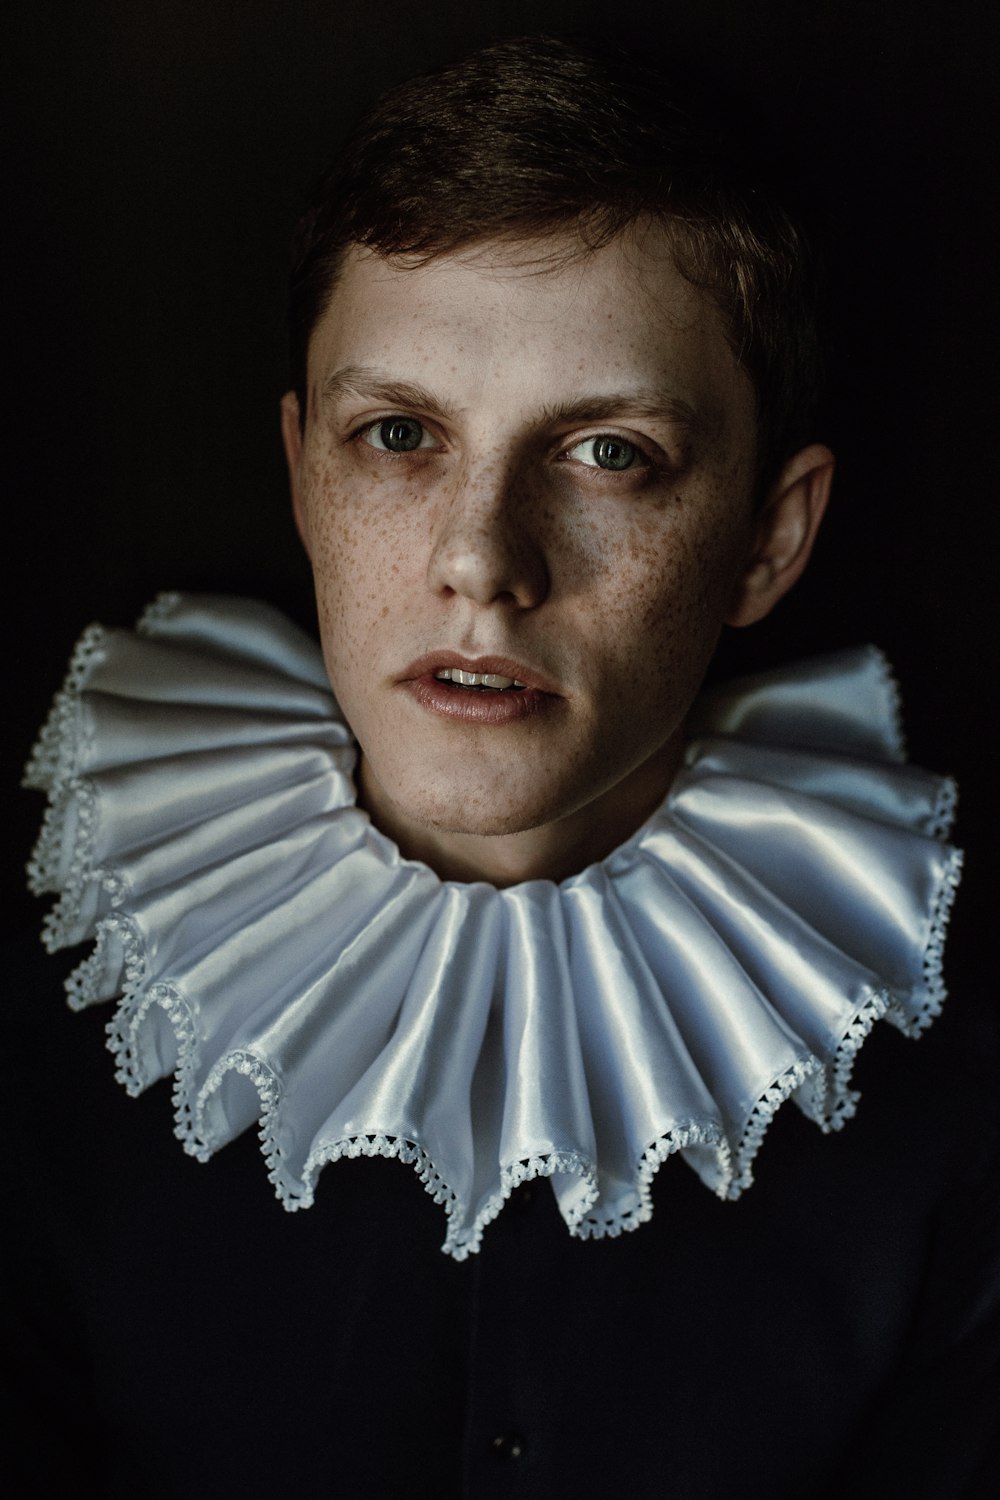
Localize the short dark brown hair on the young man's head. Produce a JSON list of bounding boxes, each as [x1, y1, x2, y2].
[[289, 36, 819, 480]]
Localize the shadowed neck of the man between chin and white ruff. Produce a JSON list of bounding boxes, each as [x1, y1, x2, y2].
[[358, 732, 684, 888]]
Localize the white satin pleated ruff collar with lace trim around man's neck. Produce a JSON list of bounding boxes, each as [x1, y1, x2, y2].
[[27, 596, 961, 1259]]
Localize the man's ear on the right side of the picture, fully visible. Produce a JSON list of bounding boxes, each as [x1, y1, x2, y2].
[[726, 443, 834, 626]]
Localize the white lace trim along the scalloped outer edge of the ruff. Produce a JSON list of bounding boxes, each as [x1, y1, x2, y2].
[[24, 609, 963, 1260]]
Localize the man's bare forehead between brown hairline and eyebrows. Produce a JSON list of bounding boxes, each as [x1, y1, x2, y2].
[[309, 230, 754, 428]]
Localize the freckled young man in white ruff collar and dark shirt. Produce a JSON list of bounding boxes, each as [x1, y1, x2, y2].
[[9, 38, 1000, 1500]]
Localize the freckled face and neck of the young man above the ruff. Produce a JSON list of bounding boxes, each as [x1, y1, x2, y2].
[[285, 234, 829, 884]]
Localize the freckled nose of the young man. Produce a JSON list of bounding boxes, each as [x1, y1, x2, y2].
[[427, 474, 549, 609]]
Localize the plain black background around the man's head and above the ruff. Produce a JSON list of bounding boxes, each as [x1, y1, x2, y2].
[[1, 0, 1000, 935]]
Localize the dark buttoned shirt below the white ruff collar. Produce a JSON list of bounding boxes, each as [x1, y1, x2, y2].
[[4, 939, 1000, 1500]]
